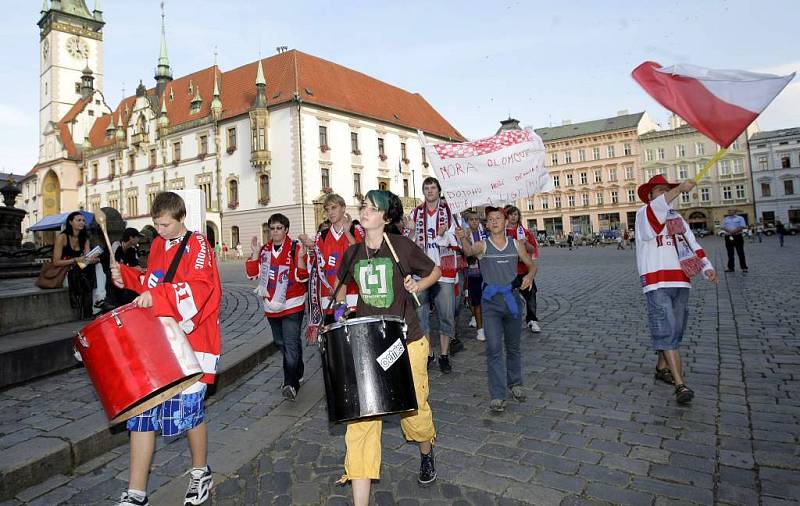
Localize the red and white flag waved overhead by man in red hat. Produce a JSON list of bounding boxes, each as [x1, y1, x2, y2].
[[631, 61, 795, 148]]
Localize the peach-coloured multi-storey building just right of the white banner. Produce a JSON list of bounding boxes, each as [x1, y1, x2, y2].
[[520, 111, 658, 238]]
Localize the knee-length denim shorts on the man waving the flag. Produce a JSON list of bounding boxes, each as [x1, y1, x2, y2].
[[645, 288, 689, 351]]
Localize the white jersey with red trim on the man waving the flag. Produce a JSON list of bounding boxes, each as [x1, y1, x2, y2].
[[636, 195, 714, 293]]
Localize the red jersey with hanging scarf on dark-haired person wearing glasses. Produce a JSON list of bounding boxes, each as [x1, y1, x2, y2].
[[244, 236, 308, 318]]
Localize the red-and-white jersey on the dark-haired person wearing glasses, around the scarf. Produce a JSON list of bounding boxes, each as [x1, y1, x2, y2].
[[244, 236, 308, 318]]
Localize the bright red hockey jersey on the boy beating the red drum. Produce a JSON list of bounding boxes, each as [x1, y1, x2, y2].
[[119, 232, 222, 384]]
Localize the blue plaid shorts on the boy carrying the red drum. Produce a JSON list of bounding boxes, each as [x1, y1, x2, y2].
[[127, 384, 207, 436]]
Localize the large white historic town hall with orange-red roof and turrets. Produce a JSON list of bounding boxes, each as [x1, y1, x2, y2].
[[23, 0, 464, 246]]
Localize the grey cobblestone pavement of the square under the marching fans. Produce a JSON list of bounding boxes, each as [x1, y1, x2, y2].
[[6, 237, 800, 506]]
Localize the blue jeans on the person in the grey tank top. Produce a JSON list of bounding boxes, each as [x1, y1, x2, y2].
[[481, 290, 524, 399]]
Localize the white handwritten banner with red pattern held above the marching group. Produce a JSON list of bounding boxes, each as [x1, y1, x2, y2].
[[419, 129, 553, 213]]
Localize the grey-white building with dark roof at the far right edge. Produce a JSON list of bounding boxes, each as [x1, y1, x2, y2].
[[750, 128, 800, 224]]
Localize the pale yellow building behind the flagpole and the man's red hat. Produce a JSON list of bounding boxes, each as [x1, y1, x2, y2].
[[639, 115, 754, 228]]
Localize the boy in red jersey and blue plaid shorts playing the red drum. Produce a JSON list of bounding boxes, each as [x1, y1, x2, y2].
[[111, 192, 222, 506]]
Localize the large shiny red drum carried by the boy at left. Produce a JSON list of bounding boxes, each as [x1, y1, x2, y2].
[[75, 303, 203, 424]]
